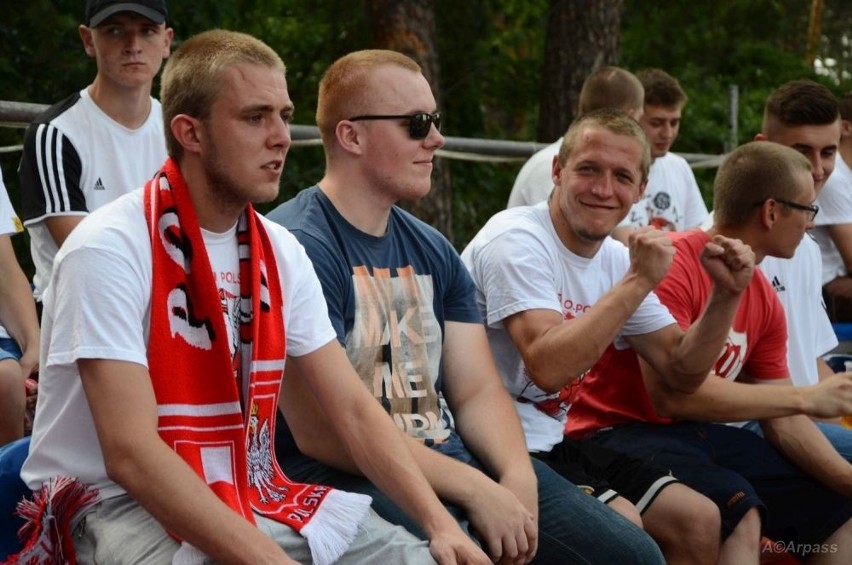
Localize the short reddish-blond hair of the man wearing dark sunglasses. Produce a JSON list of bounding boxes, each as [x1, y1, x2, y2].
[[316, 49, 421, 149]]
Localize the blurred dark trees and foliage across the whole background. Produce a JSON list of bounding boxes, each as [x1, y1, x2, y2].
[[0, 0, 852, 274]]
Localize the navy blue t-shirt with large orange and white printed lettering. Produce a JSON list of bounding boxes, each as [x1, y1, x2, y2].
[[268, 186, 482, 458]]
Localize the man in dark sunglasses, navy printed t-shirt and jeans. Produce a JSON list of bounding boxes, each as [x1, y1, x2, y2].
[[269, 50, 663, 564]]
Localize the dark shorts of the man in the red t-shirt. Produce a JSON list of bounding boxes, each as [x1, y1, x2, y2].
[[587, 422, 852, 546]]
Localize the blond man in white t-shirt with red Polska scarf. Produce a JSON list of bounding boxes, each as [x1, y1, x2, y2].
[[15, 30, 466, 564]]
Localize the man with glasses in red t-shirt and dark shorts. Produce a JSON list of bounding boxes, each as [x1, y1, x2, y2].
[[568, 141, 852, 563]]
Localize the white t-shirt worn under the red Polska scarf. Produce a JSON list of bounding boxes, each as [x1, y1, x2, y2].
[[21, 190, 336, 498]]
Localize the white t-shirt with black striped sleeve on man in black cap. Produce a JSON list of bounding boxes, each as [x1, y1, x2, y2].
[[21, 88, 167, 300]]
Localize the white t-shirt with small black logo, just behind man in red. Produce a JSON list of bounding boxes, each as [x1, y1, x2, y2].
[[760, 234, 837, 386]]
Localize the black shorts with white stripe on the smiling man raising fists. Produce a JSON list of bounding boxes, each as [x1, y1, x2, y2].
[[532, 436, 678, 514]]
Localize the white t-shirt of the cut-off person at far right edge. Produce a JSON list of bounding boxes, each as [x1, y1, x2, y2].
[[812, 153, 852, 284]]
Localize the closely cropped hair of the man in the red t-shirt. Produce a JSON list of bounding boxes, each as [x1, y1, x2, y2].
[[713, 141, 812, 228]]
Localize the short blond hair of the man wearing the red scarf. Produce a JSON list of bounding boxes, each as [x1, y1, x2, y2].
[[160, 29, 286, 159]]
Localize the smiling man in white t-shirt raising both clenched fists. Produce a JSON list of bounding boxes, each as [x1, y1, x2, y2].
[[462, 110, 754, 563]]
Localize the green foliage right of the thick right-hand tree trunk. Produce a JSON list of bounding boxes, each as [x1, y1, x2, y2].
[[619, 0, 852, 206]]
